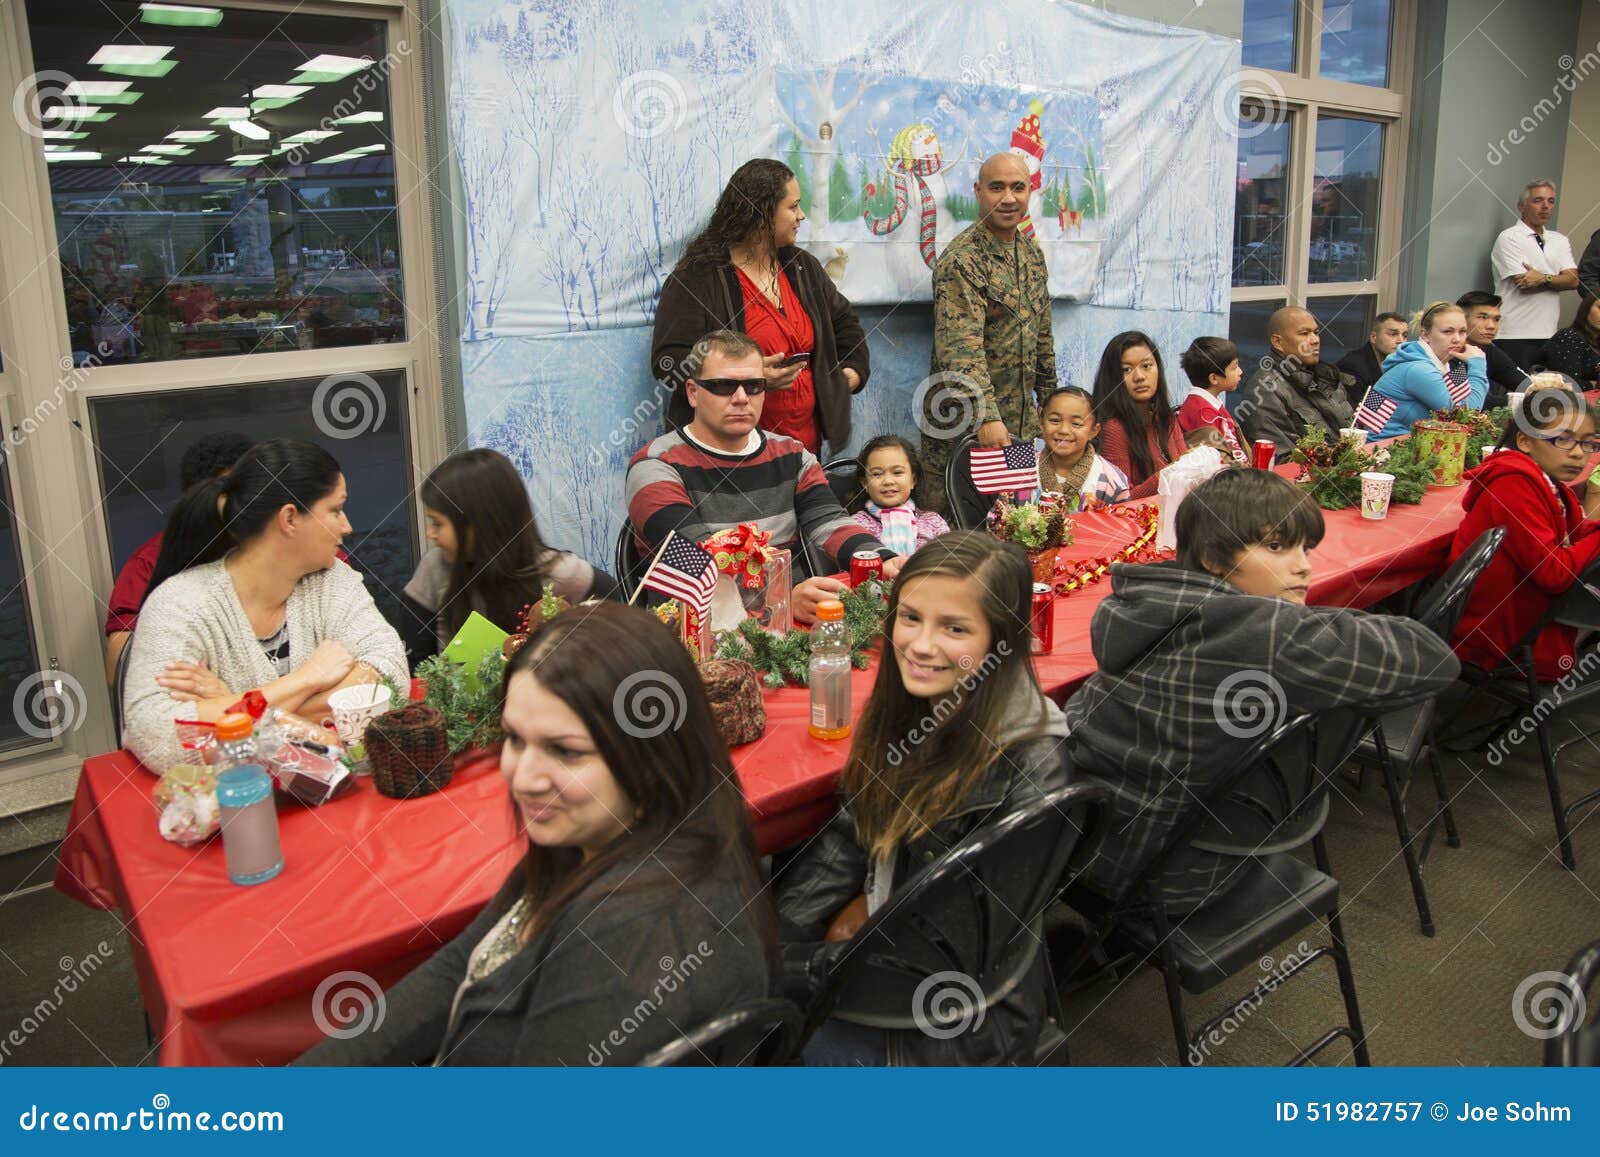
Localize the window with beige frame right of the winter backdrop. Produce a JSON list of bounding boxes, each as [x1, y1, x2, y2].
[[1230, 0, 1411, 360]]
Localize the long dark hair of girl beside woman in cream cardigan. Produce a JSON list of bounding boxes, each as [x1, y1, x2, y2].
[[419, 450, 550, 637]]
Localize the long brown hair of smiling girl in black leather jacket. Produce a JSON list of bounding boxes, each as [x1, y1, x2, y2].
[[840, 530, 1043, 858]]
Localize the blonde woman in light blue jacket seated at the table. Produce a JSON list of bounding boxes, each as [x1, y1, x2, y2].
[[1355, 301, 1490, 438]]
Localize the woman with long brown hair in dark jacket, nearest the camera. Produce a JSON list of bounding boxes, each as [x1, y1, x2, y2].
[[301, 603, 776, 1066]]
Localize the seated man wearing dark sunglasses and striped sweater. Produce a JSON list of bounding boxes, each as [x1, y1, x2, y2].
[[627, 330, 901, 623]]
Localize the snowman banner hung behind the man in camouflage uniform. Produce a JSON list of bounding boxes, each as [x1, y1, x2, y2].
[[776, 69, 1109, 304]]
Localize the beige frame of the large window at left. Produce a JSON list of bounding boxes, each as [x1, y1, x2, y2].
[[0, 0, 450, 789]]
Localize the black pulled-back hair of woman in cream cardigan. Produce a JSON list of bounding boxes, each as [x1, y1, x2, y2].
[[146, 438, 341, 597]]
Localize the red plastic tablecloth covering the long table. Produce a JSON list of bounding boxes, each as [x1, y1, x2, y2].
[[56, 488, 1461, 1064]]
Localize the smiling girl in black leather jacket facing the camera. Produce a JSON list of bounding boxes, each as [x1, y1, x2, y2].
[[778, 531, 1067, 1064]]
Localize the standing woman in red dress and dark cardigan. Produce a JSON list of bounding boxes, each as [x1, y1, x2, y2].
[[651, 158, 869, 456]]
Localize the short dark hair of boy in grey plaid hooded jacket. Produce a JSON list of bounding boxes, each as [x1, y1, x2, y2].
[[1176, 469, 1326, 578]]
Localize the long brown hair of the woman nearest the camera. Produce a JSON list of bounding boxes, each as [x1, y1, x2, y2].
[[506, 603, 778, 960]]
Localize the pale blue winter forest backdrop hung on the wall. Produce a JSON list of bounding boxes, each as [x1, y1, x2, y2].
[[450, 0, 1238, 565]]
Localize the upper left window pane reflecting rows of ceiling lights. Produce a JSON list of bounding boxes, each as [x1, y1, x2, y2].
[[22, 0, 405, 365]]
